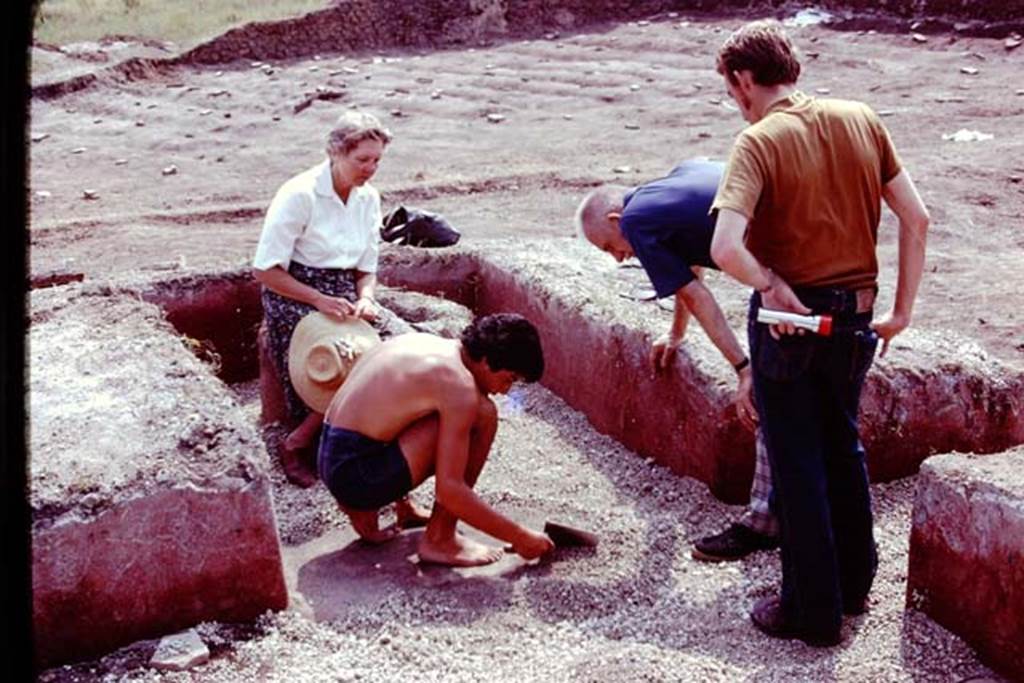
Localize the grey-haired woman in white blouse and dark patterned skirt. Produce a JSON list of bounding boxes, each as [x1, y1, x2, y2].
[[253, 111, 391, 486]]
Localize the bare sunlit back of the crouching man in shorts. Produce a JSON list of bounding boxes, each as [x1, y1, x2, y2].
[[325, 334, 481, 441]]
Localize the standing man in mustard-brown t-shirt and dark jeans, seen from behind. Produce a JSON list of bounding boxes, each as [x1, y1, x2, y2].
[[712, 20, 929, 646]]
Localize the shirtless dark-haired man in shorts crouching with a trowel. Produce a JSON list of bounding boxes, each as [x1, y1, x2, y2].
[[318, 313, 554, 566]]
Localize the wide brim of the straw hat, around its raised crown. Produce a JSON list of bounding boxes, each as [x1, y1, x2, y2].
[[288, 310, 381, 413]]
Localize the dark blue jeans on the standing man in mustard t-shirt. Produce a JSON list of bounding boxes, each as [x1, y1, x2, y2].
[[748, 289, 879, 634]]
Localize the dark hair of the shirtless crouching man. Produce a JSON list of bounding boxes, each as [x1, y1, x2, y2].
[[461, 313, 544, 382]]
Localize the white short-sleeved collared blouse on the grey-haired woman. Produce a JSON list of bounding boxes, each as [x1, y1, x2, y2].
[[253, 161, 382, 272]]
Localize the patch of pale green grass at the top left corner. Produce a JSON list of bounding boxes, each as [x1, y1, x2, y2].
[[35, 0, 328, 49]]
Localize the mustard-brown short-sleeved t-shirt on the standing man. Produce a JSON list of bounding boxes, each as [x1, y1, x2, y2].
[[712, 91, 900, 289]]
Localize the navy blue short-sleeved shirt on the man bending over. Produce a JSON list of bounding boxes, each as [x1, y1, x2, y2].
[[618, 159, 725, 297]]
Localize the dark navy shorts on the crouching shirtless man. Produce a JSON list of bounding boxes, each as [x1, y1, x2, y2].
[[316, 424, 413, 510]]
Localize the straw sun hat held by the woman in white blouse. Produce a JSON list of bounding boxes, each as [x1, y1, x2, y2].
[[288, 310, 381, 413]]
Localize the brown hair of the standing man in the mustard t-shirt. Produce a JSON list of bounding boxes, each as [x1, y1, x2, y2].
[[716, 19, 800, 86]]
